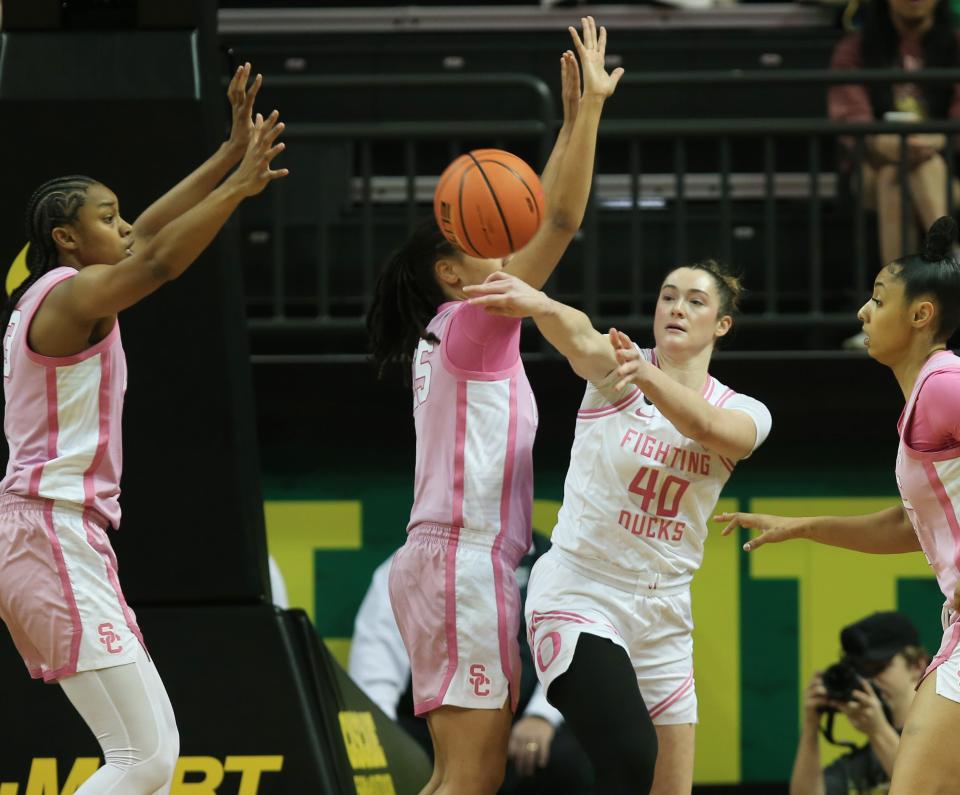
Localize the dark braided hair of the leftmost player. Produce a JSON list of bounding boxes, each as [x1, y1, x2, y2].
[[0, 175, 97, 329]]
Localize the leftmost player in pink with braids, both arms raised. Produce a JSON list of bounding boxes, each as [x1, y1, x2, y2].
[[0, 64, 286, 795]]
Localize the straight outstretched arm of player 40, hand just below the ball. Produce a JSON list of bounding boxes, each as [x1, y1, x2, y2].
[[463, 271, 617, 381]]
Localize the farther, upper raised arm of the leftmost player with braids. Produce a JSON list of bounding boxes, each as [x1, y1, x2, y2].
[[133, 64, 263, 239]]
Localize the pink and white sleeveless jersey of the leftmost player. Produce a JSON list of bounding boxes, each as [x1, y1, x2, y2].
[[0, 267, 127, 527]]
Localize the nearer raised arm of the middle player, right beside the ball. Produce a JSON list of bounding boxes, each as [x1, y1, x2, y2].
[[505, 17, 623, 289]]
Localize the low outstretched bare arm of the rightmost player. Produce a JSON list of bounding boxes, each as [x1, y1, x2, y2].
[[714, 505, 920, 555]]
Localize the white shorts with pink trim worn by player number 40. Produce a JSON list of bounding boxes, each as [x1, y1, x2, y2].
[[526, 547, 697, 725]]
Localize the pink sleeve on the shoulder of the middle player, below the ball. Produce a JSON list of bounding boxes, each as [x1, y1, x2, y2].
[[444, 303, 520, 373]]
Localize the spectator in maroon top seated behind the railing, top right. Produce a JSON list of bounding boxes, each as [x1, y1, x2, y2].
[[828, 0, 960, 352]]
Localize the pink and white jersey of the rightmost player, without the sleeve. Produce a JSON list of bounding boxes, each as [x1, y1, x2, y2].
[[896, 351, 960, 602]]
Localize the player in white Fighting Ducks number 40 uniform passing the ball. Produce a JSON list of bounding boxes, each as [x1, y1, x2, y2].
[[467, 261, 771, 795]]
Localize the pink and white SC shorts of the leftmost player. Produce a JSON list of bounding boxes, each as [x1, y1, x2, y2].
[[0, 494, 143, 682]]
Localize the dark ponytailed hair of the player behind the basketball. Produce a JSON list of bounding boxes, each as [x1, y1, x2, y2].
[[367, 218, 459, 378]]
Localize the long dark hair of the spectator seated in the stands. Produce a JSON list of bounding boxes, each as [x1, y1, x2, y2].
[[860, 0, 958, 119]]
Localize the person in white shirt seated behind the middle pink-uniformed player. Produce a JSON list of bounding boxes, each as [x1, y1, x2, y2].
[[348, 533, 594, 795]]
